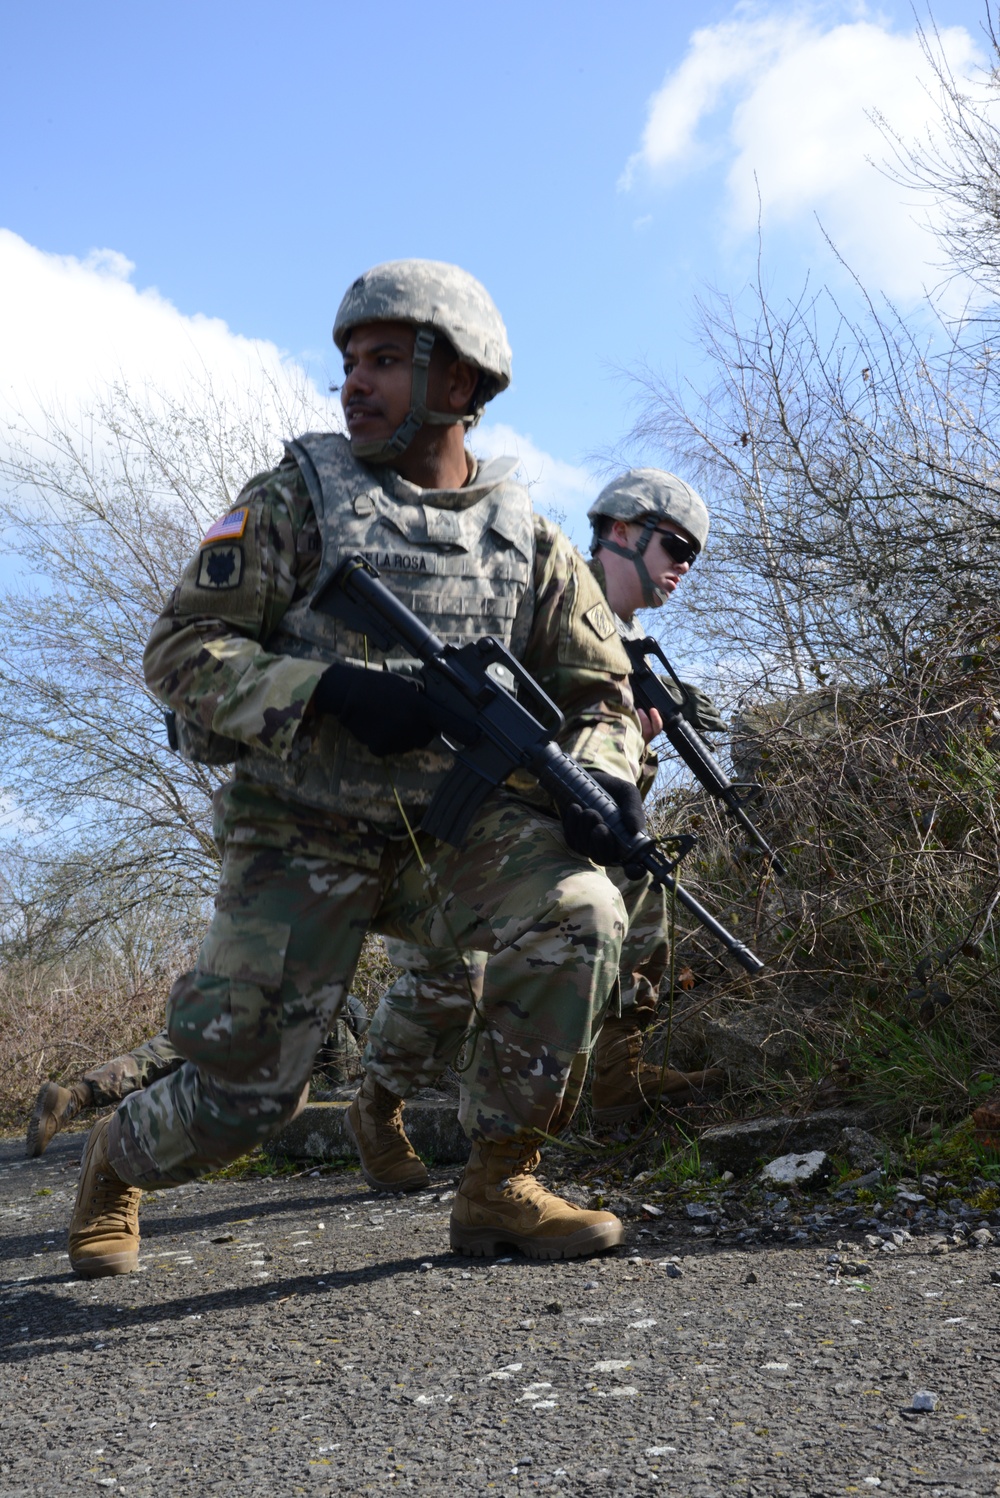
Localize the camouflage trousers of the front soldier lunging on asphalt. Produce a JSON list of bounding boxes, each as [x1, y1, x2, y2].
[[108, 797, 626, 1188]]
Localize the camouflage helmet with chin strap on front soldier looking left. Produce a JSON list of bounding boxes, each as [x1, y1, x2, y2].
[[334, 261, 510, 463]]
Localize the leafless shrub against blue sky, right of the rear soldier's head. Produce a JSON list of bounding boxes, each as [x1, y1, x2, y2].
[[627, 274, 1000, 701]]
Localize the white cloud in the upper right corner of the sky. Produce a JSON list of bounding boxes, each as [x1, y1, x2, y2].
[[621, 6, 981, 297]]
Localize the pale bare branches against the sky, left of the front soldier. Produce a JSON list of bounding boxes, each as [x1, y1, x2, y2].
[[0, 370, 335, 944]]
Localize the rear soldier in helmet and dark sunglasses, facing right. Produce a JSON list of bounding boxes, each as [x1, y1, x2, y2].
[[347, 469, 725, 1191]]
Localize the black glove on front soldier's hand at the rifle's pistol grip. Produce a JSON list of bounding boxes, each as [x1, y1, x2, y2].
[[313, 664, 469, 759]]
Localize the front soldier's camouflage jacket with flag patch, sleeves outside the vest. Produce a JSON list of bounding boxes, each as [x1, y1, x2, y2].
[[144, 443, 642, 836]]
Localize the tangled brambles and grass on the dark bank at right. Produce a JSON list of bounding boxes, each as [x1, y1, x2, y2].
[[637, 610, 1000, 1173]]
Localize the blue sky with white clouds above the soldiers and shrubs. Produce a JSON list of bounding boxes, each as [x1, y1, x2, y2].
[[0, 0, 982, 539]]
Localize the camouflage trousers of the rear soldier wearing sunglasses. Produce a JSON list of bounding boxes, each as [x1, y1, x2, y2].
[[364, 869, 669, 1098]]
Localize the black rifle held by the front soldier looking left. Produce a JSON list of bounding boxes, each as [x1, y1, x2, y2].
[[313, 556, 763, 972]]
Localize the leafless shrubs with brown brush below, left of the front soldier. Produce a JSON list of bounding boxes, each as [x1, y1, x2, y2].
[[0, 371, 344, 1122]]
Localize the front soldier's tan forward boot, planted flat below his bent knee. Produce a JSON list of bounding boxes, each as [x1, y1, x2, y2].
[[451, 1140, 624, 1258]]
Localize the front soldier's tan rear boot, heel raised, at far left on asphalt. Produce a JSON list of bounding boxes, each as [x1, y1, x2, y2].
[[69, 1113, 142, 1279]]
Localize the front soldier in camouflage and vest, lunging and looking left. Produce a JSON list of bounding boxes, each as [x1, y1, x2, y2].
[[70, 261, 655, 1275]]
